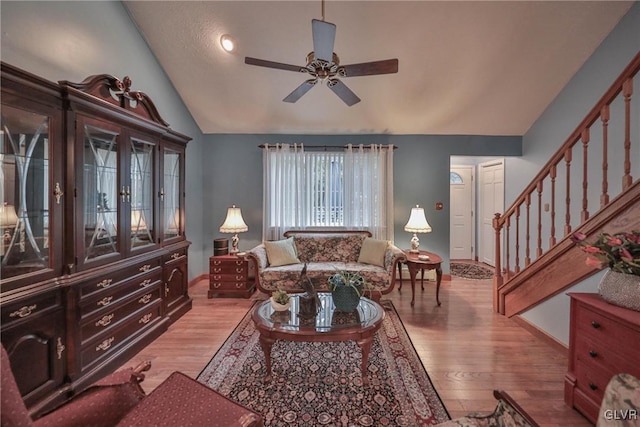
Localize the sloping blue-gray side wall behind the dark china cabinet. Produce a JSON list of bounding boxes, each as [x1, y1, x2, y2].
[[0, 1, 208, 278]]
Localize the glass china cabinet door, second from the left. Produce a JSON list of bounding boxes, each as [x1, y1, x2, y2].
[[82, 120, 120, 262]]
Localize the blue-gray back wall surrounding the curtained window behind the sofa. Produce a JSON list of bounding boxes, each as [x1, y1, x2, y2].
[[203, 134, 521, 272]]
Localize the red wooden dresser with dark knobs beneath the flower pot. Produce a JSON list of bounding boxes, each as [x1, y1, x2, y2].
[[564, 293, 640, 423]]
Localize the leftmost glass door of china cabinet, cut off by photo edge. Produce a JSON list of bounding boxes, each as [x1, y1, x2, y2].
[[0, 105, 52, 279]]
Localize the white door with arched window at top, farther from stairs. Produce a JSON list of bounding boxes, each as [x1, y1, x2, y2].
[[449, 165, 475, 259]]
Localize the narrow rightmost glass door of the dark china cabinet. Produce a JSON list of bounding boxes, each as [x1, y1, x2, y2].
[[161, 148, 182, 240]]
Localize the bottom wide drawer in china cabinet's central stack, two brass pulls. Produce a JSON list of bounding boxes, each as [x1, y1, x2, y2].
[[80, 300, 162, 371]]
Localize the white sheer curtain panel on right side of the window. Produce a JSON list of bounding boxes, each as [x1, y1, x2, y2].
[[344, 144, 394, 241]]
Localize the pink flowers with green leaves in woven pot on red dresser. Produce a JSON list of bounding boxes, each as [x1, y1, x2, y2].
[[572, 230, 640, 311]]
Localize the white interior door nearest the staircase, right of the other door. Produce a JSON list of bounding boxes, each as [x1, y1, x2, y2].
[[478, 159, 504, 266]]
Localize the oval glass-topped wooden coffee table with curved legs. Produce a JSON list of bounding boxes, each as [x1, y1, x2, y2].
[[251, 292, 385, 384]]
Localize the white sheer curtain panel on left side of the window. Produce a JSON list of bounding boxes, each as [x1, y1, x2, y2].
[[262, 144, 306, 240]]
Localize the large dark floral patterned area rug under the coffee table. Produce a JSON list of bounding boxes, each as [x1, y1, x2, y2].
[[197, 301, 450, 426]]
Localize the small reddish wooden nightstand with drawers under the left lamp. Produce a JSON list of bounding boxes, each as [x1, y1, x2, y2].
[[207, 255, 256, 298]]
